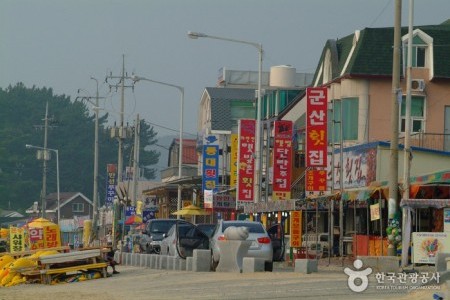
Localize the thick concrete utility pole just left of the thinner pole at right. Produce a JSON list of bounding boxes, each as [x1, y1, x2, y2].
[[388, 0, 402, 256]]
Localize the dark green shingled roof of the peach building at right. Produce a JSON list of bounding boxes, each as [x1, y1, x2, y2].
[[314, 20, 450, 82]]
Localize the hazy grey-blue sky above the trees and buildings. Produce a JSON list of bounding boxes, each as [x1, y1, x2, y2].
[[0, 0, 450, 142]]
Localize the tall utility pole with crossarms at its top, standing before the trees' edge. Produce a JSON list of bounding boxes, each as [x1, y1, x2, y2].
[[105, 54, 134, 184]]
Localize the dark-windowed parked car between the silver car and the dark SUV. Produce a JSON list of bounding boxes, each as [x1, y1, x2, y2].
[[161, 221, 209, 258]]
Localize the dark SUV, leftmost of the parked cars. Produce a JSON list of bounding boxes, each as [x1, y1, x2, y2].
[[139, 219, 181, 254]]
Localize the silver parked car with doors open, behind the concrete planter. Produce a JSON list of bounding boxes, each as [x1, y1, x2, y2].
[[210, 221, 283, 272]]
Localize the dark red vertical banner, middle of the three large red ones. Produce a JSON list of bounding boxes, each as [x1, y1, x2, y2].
[[272, 121, 293, 200]]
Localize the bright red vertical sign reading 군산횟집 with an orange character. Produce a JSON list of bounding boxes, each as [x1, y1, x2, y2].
[[305, 87, 328, 167]]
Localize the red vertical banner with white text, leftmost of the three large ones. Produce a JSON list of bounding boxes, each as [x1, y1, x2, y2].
[[236, 119, 256, 204]]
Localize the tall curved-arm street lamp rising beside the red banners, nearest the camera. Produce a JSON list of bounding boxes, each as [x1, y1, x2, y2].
[[187, 31, 267, 202]]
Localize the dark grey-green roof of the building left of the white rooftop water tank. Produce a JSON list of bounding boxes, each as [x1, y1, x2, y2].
[[205, 87, 256, 130]]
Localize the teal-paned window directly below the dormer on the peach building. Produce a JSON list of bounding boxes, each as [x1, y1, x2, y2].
[[400, 96, 425, 133]]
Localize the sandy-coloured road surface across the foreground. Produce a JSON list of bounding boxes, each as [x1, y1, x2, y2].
[[0, 264, 442, 300]]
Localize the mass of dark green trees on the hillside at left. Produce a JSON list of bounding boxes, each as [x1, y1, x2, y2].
[[0, 83, 159, 212]]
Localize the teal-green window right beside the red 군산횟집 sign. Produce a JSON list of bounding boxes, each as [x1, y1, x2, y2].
[[328, 98, 359, 143]]
